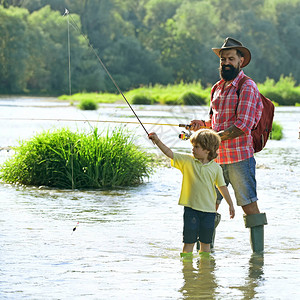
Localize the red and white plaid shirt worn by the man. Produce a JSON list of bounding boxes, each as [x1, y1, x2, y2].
[[211, 71, 263, 164]]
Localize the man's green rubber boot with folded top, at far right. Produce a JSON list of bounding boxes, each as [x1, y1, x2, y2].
[[244, 213, 268, 253]]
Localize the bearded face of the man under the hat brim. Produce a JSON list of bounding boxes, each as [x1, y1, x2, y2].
[[219, 49, 244, 81]]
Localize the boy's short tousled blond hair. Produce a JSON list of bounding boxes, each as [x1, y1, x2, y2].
[[190, 129, 221, 160]]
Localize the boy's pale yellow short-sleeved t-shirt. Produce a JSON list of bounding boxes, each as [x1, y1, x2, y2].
[[171, 153, 226, 212]]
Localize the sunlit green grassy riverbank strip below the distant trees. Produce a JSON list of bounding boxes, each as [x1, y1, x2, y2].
[[58, 77, 300, 106]]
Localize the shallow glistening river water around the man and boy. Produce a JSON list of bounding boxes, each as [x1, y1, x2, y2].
[[0, 98, 300, 300]]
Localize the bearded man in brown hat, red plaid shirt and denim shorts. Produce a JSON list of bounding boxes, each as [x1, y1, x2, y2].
[[190, 37, 267, 252]]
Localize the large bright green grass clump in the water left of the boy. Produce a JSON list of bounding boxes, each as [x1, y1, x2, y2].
[[0, 127, 152, 189]]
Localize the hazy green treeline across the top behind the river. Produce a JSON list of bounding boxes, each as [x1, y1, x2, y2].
[[0, 0, 300, 95]]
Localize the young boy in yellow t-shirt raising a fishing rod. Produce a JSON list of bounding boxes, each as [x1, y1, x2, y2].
[[149, 129, 235, 256]]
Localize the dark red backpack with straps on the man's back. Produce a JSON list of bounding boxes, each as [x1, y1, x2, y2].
[[212, 76, 275, 153]]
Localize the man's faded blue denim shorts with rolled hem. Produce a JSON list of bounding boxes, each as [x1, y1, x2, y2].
[[217, 157, 258, 206]]
